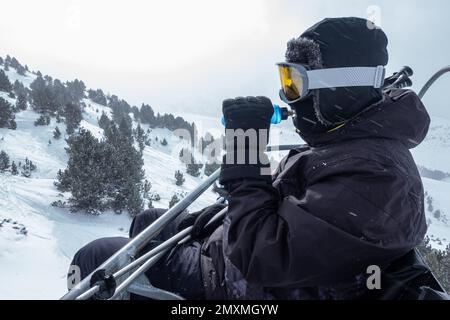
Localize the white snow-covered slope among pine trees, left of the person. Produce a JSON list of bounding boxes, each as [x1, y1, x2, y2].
[[0, 68, 216, 299]]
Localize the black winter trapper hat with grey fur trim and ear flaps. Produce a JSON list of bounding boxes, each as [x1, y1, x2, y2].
[[286, 17, 389, 135]]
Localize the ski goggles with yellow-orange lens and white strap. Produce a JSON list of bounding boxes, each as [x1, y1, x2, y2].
[[277, 62, 385, 103]]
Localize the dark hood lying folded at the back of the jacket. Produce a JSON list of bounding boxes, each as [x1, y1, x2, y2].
[[300, 90, 430, 149]]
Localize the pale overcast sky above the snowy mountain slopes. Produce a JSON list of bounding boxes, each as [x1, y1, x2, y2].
[[0, 0, 450, 117]]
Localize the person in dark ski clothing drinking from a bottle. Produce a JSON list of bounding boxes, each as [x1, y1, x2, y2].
[[72, 18, 430, 299]]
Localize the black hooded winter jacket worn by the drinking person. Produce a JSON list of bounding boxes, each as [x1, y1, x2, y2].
[[202, 90, 430, 299]]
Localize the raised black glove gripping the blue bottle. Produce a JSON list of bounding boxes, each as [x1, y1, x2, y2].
[[219, 97, 273, 185]]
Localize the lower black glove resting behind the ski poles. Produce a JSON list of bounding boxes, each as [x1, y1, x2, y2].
[[178, 203, 227, 239]]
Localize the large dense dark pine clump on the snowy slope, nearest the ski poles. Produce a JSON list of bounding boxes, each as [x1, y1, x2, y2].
[[55, 123, 144, 216]]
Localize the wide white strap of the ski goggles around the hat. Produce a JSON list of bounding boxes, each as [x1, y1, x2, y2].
[[307, 66, 385, 90]]
